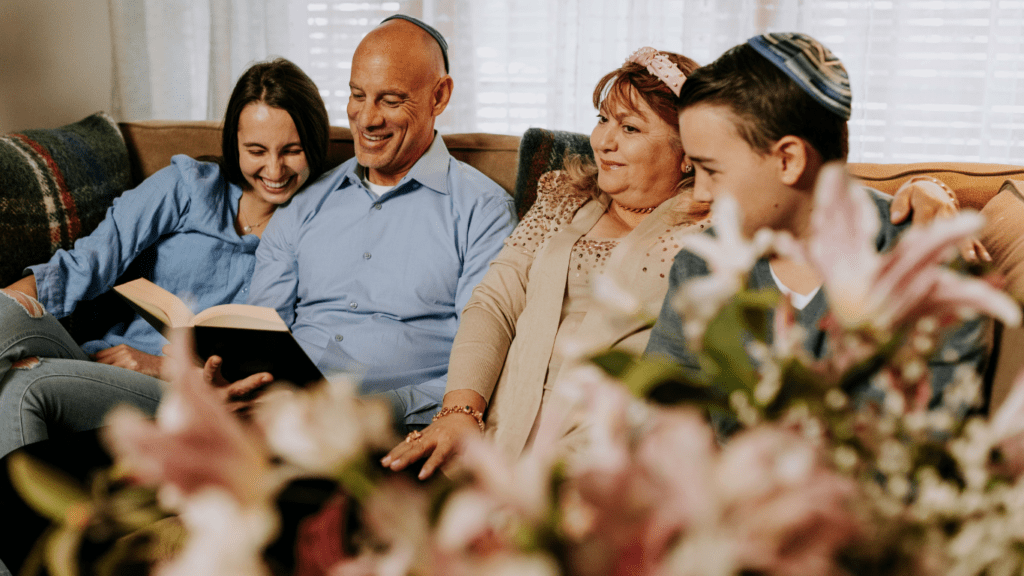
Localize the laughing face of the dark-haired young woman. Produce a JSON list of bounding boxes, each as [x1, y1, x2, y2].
[[239, 101, 309, 205]]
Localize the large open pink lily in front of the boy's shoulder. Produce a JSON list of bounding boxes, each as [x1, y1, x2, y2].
[[808, 164, 1021, 334]]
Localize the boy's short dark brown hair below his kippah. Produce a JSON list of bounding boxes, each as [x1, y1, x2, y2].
[[679, 44, 850, 162]]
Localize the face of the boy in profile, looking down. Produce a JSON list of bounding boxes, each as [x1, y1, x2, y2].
[[679, 104, 807, 237]]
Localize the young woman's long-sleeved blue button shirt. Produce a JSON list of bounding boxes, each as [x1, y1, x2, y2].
[[26, 155, 259, 354]]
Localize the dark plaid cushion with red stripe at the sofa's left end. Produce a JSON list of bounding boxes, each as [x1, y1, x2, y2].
[[0, 113, 131, 286]]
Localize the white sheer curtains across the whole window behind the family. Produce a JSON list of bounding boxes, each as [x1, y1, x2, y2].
[[110, 0, 1024, 164]]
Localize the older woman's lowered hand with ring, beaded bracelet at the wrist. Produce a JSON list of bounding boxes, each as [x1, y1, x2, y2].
[[381, 389, 486, 480]]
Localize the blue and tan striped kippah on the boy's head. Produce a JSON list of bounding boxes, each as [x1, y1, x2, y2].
[[746, 32, 853, 120]]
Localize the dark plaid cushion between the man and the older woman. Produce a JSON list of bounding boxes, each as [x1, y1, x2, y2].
[[515, 128, 594, 218]]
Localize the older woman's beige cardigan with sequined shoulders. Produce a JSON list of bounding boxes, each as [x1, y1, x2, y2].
[[445, 172, 703, 457]]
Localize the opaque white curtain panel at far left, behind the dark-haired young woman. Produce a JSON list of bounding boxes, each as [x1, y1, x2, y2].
[[109, 0, 307, 120]]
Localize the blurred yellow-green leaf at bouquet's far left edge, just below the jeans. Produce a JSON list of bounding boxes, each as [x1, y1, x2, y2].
[[8, 452, 89, 525]]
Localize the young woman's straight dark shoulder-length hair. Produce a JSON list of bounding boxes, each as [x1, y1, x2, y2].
[[220, 58, 331, 188]]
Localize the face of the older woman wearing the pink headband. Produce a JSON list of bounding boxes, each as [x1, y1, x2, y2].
[[590, 87, 683, 208]]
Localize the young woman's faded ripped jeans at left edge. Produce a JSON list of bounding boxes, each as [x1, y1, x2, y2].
[[0, 292, 163, 457]]
